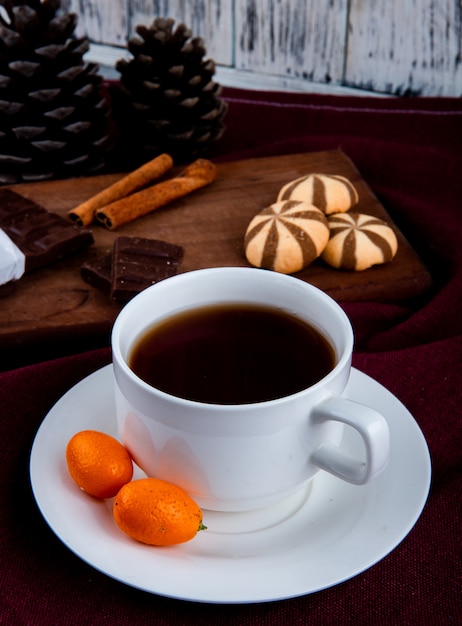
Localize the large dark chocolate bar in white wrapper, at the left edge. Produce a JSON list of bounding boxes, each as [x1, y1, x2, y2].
[[0, 189, 94, 272]]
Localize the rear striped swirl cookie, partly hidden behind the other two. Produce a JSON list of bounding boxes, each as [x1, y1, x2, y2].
[[277, 174, 359, 215]]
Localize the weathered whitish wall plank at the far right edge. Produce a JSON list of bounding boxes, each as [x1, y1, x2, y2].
[[345, 0, 462, 96]]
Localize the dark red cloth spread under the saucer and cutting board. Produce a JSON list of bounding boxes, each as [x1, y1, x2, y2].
[[0, 89, 462, 626]]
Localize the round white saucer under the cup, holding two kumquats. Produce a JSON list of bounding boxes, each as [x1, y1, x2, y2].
[[30, 365, 431, 603]]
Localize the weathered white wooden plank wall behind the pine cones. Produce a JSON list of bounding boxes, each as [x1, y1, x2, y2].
[[62, 0, 462, 97]]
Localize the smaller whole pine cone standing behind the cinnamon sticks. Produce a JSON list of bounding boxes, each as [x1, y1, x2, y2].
[[111, 18, 227, 162]]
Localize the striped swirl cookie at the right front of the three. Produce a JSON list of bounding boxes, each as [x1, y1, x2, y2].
[[322, 212, 398, 271]]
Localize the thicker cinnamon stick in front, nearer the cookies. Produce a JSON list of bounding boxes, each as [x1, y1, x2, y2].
[[96, 159, 216, 230]]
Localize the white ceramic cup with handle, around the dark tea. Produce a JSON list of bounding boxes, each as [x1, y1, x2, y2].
[[112, 268, 389, 511]]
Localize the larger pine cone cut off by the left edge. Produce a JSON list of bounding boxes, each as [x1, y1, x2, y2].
[[0, 0, 109, 183]]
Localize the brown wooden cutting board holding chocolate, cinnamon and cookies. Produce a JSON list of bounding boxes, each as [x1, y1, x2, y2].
[[0, 151, 431, 348]]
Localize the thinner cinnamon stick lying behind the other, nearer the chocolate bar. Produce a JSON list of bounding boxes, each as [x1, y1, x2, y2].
[[68, 154, 173, 226]]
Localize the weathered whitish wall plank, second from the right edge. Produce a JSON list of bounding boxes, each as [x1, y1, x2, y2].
[[235, 0, 348, 84]]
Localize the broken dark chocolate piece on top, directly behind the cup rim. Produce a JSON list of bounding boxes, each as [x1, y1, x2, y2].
[[111, 237, 183, 302]]
